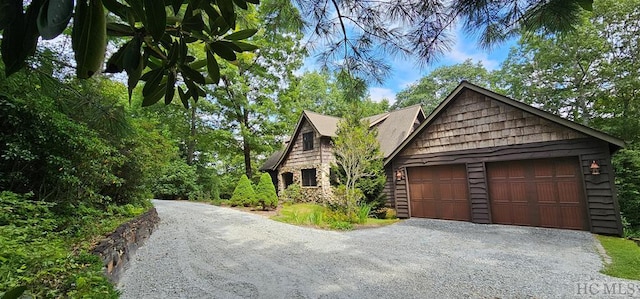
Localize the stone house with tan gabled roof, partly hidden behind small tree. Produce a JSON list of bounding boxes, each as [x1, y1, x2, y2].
[[260, 105, 425, 202]]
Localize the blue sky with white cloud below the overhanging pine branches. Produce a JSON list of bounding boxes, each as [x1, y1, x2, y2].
[[302, 28, 516, 103]]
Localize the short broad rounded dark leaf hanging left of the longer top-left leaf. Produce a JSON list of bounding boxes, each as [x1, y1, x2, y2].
[[38, 0, 73, 39]]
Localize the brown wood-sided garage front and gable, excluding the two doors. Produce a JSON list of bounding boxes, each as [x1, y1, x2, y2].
[[385, 83, 623, 235]]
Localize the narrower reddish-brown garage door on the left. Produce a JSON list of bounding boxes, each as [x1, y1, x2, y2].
[[408, 164, 471, 221]]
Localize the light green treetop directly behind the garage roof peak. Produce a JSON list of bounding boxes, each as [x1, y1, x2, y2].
[[392, 59, 494, 114]]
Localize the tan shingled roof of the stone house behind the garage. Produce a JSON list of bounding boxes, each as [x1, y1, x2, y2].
[[260, 105, 424, 171]]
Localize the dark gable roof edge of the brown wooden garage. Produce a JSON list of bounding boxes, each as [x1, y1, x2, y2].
[[384, 81, 624, 165]]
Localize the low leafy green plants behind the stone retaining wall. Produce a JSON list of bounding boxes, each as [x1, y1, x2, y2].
[[0, 192, 131, 298]]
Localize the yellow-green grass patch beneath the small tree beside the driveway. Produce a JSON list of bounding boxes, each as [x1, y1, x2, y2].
[[271, 203, 399, 230]]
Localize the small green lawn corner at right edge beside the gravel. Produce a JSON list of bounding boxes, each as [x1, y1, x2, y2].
[[597, 236, 640, 280]]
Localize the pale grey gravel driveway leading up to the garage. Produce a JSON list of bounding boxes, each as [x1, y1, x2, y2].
[[118, 201, 640, 298]]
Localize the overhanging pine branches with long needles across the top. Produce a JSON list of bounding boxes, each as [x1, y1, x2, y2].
[[296, 0, 593, 81]]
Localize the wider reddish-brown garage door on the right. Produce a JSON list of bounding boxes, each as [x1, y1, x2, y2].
[[487, 157, 588, 230]]
